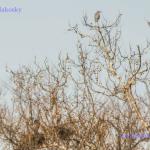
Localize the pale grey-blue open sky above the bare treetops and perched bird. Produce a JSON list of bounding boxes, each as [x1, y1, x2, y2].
[[0, 0, 150, 80]]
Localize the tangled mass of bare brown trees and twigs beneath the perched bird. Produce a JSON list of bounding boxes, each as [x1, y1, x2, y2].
[[0, 14, 150, 150]]
